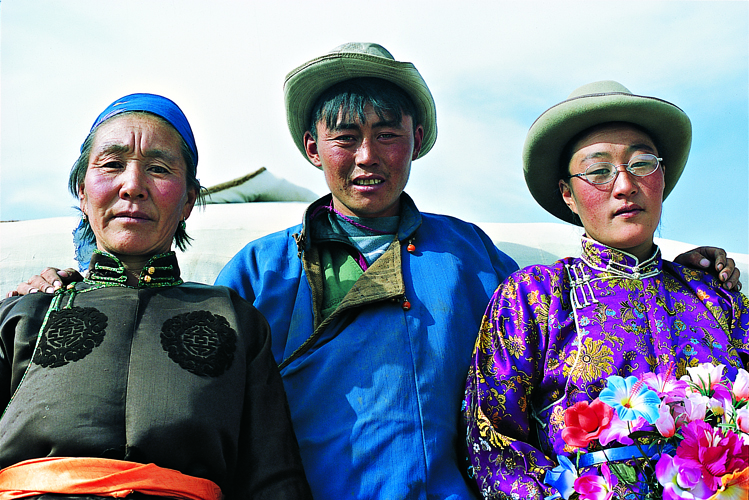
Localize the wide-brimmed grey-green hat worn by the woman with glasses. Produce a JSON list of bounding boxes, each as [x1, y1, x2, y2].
[[523, 80, 692, 226]]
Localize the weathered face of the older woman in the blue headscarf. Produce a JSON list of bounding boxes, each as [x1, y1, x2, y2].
[[79, 114, 197, 257]]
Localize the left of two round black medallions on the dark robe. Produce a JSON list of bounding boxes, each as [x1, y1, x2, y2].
[[33, 307, 107, 368]]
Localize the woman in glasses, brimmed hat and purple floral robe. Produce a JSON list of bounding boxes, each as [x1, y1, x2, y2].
[[465, 81, 749, 499]]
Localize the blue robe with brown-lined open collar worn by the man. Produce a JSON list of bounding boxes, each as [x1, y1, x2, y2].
[[216, 194, 517, 500]]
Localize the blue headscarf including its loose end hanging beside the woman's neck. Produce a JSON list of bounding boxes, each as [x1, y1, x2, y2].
[[73, 94, 198, 272]]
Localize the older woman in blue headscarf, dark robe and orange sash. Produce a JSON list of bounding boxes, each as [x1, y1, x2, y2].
[[0, 94, 309, 499]]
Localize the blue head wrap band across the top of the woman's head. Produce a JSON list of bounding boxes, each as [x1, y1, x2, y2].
[[81, 94, 198, 166]]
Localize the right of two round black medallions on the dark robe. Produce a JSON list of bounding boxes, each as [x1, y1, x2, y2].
[[161, 311, 237, 377]]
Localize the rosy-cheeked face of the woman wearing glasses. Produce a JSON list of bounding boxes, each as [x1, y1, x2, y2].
[[559, 124, 665, 260]]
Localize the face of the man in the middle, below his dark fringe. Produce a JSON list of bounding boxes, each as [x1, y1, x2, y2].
[[304, 106, 424, 217]]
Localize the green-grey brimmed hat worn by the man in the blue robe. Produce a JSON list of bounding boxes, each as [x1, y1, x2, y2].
[[283, 43, 437, 167]]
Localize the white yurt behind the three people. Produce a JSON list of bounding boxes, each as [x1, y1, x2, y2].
[[0, 168, 749, 296]]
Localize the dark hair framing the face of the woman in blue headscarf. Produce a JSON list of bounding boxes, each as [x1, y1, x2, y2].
[[68, 111, 205, 252]]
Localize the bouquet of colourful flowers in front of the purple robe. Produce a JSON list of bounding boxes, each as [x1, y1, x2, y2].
[[544, 363, 749, 500]]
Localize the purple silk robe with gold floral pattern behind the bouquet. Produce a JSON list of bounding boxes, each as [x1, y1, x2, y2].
[[464, 238, 749, 500]]
